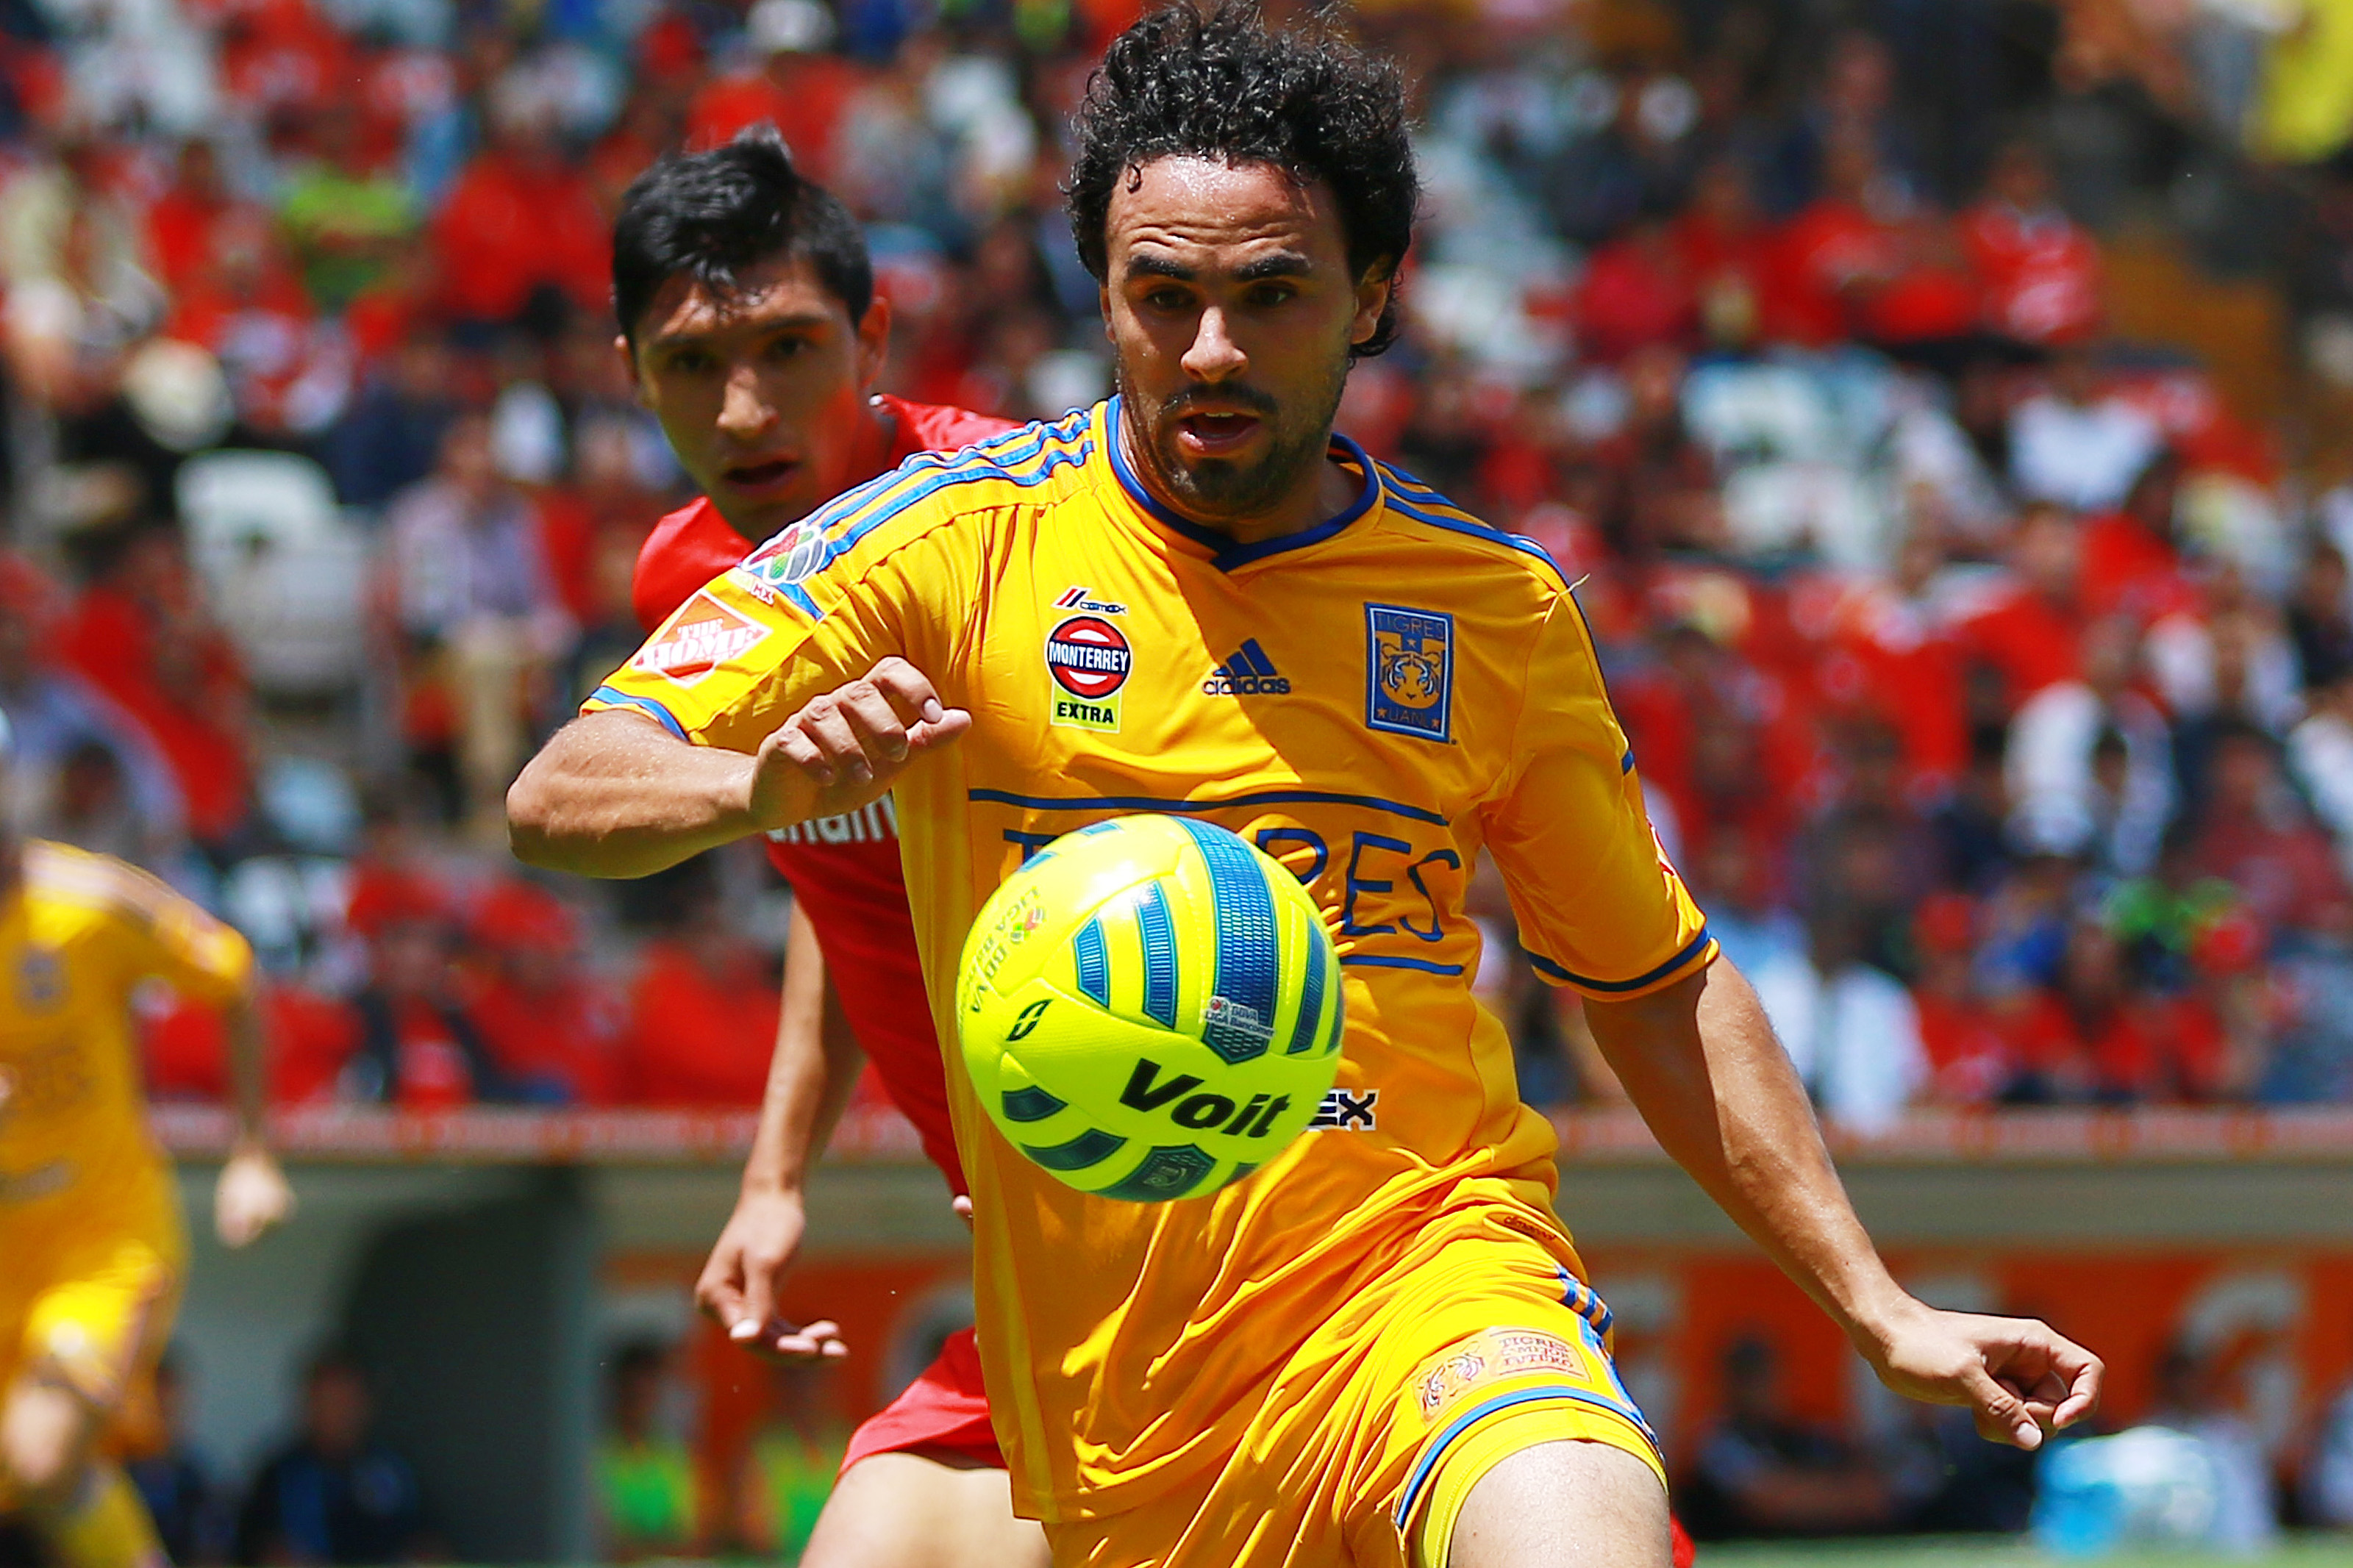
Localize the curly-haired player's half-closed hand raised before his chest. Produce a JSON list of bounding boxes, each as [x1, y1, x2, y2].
[[751, 656, 972, 828]]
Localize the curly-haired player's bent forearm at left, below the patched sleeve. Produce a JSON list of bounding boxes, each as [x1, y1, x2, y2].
[[506, 710, 763, 877]]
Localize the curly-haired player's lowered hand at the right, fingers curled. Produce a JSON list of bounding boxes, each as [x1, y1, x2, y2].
[[1863, 1303, 2108, 1450]]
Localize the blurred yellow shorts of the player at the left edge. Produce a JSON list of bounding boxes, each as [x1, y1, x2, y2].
[[0, 1218, 181, 1453]]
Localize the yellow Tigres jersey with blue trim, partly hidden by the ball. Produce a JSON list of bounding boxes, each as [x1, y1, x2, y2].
[[588, 402, 1713, 1519]]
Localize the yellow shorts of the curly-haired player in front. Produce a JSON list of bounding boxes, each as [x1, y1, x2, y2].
[[1047, 1203, 1666, 1568]]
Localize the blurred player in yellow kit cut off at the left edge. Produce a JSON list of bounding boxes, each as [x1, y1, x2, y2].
[[0, 717, 292, 1568]]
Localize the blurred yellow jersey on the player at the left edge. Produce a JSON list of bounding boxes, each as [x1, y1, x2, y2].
[[0, 842, 251, 1253]]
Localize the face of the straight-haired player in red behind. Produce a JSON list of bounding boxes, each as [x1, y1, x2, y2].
[[621, 257, 890, 541]]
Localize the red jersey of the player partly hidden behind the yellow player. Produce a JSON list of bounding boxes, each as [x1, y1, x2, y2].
[[631, 397, 1014, 1192]]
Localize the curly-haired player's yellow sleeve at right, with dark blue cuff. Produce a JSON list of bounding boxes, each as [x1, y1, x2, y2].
[[1482, 595, 1715, 999]]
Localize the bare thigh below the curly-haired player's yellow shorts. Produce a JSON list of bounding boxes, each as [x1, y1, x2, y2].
[[1414, 1441, 1673, 1568]]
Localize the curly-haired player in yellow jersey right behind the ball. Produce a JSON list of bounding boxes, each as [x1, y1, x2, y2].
[[508, 7, 2102, 1568]]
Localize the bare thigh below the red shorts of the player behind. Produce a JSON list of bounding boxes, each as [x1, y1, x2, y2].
[[800, 1453, 1049, 1568]]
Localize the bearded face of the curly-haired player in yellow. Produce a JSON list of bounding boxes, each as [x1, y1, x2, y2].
[[1104, 157, 1388, 543]]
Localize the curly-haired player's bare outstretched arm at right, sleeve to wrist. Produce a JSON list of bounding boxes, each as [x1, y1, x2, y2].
[[1586, 959, 1908, 1342]]
